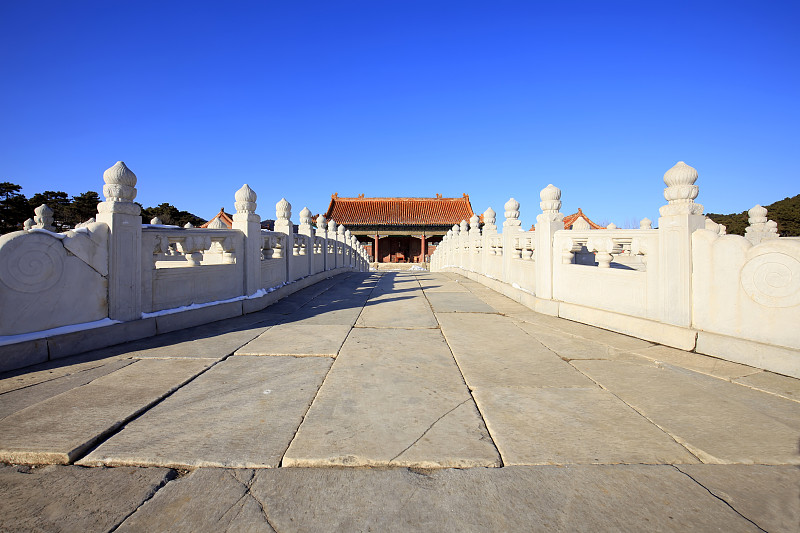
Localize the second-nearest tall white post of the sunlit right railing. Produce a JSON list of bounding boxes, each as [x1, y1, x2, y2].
[[534, 183, 564, 300]]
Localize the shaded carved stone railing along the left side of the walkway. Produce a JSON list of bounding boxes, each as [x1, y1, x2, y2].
[[0, 161, 369, 370]]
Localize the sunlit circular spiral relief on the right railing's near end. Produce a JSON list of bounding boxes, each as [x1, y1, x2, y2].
[[741, 252, 800, 307]]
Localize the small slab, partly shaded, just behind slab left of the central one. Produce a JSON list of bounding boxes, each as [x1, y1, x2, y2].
[[235, 323, 351, 357]]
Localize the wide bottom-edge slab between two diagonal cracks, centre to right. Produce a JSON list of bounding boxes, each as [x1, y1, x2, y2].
[[247, 465, 758, 533]]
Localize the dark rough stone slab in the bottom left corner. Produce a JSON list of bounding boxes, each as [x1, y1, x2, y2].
[[0, 465, 173, 532]]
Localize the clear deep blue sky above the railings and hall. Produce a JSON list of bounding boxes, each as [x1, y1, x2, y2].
[[0, 0, 800, 225]]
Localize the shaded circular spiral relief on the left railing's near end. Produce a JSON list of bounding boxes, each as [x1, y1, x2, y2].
[[0, 235, 64, 293]]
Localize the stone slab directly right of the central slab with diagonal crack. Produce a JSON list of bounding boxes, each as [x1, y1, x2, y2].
[[474, 387, 697, 465]]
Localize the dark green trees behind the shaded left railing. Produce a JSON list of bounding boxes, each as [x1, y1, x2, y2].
[[0, 181, 205, 234]]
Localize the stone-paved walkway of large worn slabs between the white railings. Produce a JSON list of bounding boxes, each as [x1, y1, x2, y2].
[[0, 272, 800, 532]]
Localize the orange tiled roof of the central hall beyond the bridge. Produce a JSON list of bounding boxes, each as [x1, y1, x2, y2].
[[325, 193, 474, 226]]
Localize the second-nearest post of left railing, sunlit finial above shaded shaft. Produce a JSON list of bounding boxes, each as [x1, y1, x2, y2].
[[233, 183, 263, 296]]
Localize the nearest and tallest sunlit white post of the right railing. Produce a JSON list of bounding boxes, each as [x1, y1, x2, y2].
[[648, 161, 706, 327]]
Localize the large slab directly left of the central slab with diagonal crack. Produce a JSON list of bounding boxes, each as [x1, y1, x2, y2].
[[78, 356, 332, 468]]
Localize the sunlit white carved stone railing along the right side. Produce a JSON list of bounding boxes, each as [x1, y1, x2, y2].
[[431, 162, 800, 377]]
